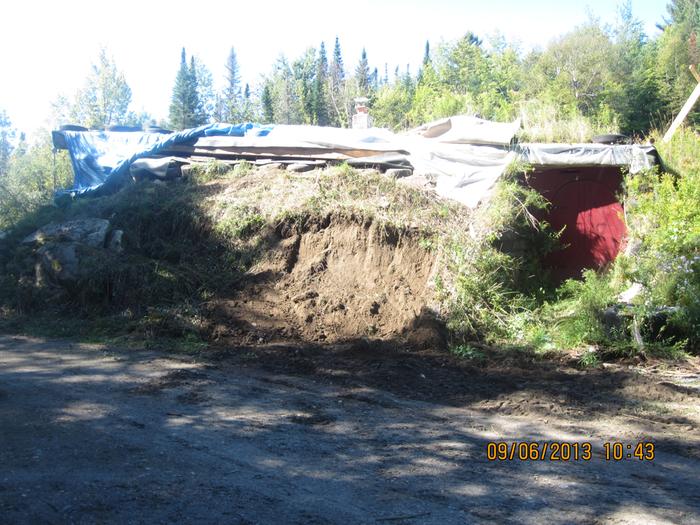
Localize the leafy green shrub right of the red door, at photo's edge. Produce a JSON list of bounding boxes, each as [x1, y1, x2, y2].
[[619, 129, 700, 347]]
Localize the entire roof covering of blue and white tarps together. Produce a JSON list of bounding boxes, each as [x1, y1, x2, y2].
[[54, 116, 653, 206]]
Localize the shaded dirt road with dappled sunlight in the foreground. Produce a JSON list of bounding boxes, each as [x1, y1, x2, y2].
[[0, 336, 700, 525]]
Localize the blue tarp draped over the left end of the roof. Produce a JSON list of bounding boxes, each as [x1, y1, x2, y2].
[[61, 123, 273, 195]]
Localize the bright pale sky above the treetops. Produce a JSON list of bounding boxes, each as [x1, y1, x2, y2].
[[0, 0, 668, 131]]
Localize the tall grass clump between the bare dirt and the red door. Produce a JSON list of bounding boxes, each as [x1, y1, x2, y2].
[[436, 166, 557, 345]]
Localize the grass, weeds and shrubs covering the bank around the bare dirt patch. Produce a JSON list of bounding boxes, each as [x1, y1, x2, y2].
[[0, 147, 700, 360]]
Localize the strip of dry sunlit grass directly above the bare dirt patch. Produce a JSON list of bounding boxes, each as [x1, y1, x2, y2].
[[204, 166, 470, 237]]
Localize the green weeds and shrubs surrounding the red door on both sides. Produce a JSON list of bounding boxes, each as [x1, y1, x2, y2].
[[437, 129, 700, 360]]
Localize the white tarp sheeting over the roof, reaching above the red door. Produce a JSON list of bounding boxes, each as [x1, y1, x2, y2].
[[186, 116, 653, 207]]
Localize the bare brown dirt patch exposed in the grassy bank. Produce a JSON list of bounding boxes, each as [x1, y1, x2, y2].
[[217, 211, 441, 345]]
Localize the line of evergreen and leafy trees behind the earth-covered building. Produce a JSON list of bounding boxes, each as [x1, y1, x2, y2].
[[5, 0, 700, 139]]
